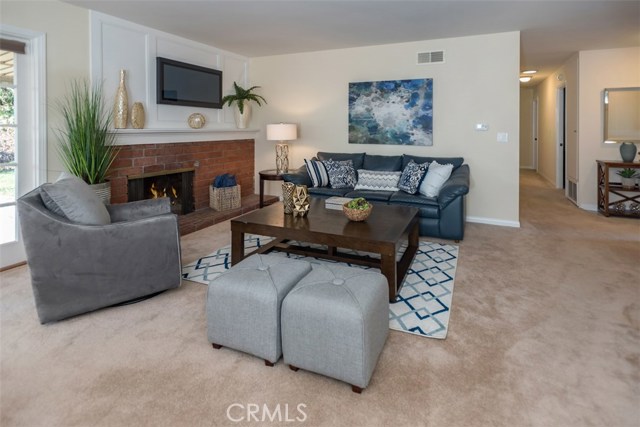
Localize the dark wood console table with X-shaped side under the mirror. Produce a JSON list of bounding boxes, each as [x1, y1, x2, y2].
[[596, 160, 640, 218]]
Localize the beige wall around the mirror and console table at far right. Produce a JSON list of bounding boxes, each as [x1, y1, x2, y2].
[[578, 47, 640, 210]]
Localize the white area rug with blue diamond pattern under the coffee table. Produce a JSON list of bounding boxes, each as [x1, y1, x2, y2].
[[182, 234, 458, 339]]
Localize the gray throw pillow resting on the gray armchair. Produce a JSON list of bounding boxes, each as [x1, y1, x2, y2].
[[40, 176, 111, 225]]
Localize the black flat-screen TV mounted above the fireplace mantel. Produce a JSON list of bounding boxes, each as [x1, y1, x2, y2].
[[156, 57, 222, 108]]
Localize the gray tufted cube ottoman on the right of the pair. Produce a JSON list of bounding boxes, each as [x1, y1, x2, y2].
[[282, 264, 389, 393]]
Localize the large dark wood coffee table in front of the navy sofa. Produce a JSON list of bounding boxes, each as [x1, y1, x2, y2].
[[231, 198, 419, 301]]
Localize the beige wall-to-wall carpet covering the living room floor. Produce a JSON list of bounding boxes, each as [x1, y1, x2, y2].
[[0, 172, 640, 427]]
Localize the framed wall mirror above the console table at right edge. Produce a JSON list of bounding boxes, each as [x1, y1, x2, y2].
[[604, 87, 640, 143]]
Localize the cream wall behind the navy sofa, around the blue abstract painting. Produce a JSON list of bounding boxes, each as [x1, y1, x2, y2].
[[251, 32, 520, 225]]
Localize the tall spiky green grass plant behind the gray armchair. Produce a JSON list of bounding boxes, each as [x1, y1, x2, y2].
[[58, 81, 119, 204]]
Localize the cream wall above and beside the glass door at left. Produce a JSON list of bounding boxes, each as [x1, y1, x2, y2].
[[0, 0, 89, 181]]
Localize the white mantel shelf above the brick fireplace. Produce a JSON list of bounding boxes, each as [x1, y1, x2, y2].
[[112, 128, 260, 145]]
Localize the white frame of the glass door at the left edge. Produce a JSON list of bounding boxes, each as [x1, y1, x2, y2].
[[0, 25, 47, 270]]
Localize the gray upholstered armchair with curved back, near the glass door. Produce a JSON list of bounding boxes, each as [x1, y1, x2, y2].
[[18, 179, 181, 323]]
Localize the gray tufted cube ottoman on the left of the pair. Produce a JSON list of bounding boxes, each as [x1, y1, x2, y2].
[[207, 254, 311, 366]]
